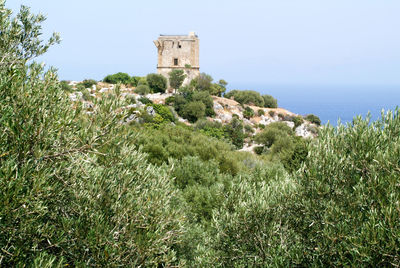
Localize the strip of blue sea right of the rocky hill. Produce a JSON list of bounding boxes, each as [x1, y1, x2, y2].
[[230, 85, 400, 126]]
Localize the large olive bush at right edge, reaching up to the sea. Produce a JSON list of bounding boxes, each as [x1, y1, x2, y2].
[[293, 109, 400, 267]]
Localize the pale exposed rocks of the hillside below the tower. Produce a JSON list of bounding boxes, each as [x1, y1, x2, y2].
[[69, 81, 319, 151]]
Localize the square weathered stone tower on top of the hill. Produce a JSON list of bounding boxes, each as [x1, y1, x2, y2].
[[154, 32, 200, 85]]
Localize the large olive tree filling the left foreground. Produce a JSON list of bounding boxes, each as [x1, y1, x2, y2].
[[0, 3, 185, 267]]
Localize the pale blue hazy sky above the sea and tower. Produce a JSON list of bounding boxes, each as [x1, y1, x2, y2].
[[6, 0, 400, 85]]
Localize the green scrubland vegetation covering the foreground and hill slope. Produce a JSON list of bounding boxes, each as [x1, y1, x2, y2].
[[0, 2, 400, 267]]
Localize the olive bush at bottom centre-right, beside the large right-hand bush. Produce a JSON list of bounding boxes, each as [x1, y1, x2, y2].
[[194, 165, 303, 267]]
